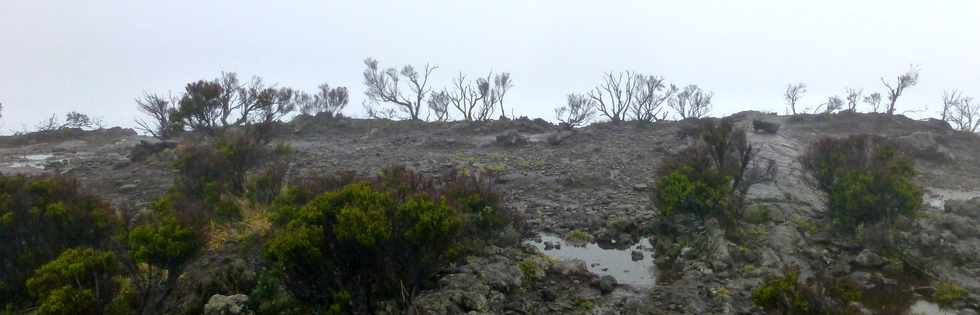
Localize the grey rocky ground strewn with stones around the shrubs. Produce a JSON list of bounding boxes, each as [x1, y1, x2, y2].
[[0, 112, 980, 314]]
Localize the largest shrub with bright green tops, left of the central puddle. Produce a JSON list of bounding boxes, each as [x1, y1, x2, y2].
[[265, 167, 511, 312]]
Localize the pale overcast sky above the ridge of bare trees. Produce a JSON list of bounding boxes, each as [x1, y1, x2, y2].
[[0, 0, 980, 132]]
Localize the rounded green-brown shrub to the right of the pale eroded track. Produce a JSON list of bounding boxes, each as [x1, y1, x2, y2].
[[801, 135, 922, 229]]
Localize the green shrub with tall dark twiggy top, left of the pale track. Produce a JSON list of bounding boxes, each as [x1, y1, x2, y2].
[[653, 119, 776, 221]]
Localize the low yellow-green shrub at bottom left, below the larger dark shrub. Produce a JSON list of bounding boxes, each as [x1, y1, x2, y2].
[[26, 248, 117, 314]]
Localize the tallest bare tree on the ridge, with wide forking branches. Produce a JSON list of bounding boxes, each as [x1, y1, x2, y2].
[[364, 58, 438, 120]]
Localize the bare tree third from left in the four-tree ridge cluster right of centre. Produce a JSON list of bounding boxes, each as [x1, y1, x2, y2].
[[630, 75, 677, 122]]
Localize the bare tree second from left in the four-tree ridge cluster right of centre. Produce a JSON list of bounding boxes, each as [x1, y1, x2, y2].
[[589, 71, 642, 122]]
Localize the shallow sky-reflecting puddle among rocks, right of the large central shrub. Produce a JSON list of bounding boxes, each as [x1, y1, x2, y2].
[[527, 233, 656, 288]]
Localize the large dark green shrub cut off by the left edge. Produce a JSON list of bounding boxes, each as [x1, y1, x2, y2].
[[0, 176, 120, 305]]
